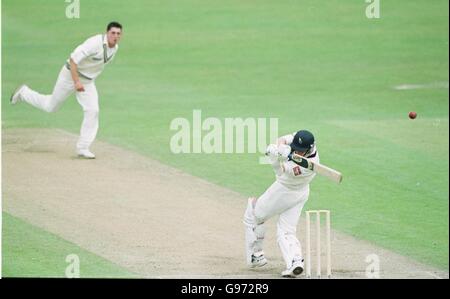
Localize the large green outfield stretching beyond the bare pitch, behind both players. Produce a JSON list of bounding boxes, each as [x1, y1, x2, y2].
[[2, 0, 449, 273]]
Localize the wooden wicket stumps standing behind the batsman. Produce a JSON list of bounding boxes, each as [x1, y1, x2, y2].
[[306, 210, 331, 278]]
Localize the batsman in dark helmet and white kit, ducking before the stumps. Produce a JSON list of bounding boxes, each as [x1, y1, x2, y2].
[[244, 130, 319, 277]]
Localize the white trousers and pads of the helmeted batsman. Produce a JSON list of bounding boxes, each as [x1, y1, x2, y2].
[[244, 181, 309, 268]]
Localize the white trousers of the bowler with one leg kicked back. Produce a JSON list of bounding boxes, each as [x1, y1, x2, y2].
[[20, 66, 99, 149]]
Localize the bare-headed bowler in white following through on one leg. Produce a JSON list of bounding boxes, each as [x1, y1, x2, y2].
[[10, 22, 122, 159]]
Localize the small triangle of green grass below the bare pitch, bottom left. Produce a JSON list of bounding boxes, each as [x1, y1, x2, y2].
[[2, 213, 136, 278]]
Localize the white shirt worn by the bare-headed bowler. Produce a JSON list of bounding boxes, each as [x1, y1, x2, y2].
[[67, 34, 119, 80]]
